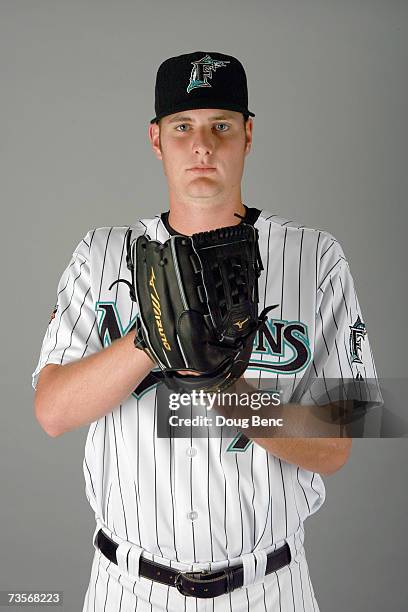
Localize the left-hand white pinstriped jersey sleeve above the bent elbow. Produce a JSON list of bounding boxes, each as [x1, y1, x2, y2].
[[32, 231, 103, 389]]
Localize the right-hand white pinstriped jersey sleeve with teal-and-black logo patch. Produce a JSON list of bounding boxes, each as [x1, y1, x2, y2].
[[301, 243, 384, 408]]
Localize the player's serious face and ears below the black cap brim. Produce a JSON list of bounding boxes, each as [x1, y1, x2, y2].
[[149, 108, 252, 201]]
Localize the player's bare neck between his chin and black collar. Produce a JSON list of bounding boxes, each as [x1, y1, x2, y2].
[[168, 200, 245, 236]]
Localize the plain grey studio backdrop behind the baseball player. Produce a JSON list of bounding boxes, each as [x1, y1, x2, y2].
[[0, 0, 408, 612]]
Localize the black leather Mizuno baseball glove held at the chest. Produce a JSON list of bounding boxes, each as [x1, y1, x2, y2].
[[115, 215, 274, 392]]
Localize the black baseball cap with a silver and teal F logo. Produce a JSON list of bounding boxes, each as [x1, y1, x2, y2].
[[150, 51, 255, 123]]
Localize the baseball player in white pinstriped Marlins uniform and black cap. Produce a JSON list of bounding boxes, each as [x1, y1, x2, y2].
[[32, 51, 380, 612]]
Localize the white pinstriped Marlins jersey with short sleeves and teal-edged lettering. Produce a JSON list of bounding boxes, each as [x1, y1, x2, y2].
[[32, 211, 382, 567]]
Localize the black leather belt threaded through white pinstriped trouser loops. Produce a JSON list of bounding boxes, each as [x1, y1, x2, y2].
[[96, 529, 291, 597]]
